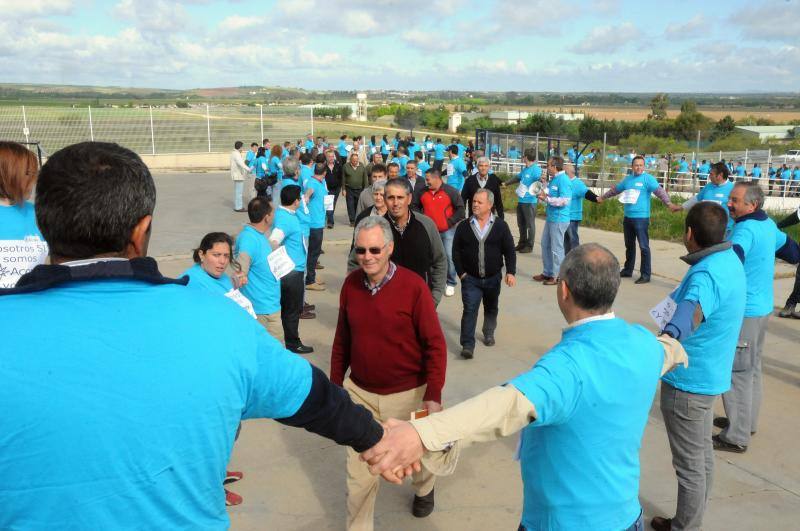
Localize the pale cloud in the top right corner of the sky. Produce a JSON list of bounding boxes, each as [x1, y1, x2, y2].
[[728, 0, 800, 43]]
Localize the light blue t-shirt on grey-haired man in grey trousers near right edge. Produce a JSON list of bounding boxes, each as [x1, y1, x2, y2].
[[731, 215, 786, 317]]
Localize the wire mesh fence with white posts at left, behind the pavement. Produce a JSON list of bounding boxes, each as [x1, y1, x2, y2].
[[0, 104, 313, 154]]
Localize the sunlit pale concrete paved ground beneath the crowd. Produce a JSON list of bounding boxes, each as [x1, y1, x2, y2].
[[150, 173, 800, 531]]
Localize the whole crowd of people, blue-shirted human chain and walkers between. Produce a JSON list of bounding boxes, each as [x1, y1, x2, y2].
[[0, 135, 800, 530]]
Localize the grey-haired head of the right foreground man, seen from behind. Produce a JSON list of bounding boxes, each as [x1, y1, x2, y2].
[[559, 243, 620, 313]]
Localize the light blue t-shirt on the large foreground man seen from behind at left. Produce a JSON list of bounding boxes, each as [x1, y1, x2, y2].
[[0, 279, 312, 531]]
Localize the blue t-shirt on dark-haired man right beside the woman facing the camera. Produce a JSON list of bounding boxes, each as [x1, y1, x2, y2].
[[233, 225, 281, 315]]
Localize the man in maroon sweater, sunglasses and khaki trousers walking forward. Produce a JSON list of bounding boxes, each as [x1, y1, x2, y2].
[[331, 216, 447, 530]]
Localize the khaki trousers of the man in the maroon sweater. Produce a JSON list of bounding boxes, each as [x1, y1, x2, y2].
[[344, 378, 436, 531]]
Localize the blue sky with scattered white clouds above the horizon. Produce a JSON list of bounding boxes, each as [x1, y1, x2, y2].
[[0, 0, 800, 92]]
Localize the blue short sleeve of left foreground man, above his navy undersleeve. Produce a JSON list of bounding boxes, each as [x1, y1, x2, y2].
[[242, 324, 311, 419]]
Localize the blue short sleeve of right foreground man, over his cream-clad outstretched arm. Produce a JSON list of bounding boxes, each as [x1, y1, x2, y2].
[[508, 351, 582, 426]]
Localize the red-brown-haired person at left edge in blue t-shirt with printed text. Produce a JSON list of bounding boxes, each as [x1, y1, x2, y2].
[[0, 142, 49, 288]]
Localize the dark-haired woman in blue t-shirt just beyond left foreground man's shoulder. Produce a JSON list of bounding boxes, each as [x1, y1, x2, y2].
[[182, 232, 247, 505]]
